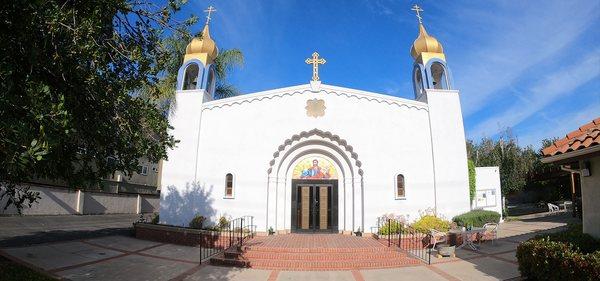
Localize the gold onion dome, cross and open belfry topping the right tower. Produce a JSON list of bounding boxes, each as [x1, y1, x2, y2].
[[410, 5, 452, 100]]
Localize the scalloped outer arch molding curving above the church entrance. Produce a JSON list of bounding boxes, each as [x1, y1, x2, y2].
[[267, 128, 363, 177]]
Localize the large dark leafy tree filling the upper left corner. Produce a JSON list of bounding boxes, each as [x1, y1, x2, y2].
[[0, 0, 196, 210]]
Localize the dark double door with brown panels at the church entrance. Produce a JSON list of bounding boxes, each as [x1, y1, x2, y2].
[[291, 180, 338, 232]]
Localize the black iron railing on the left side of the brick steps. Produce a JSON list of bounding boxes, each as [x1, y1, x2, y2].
[[198, 216, 256, 263]]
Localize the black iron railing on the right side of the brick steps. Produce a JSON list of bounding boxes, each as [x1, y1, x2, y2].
[[376, 217, 431, 264]]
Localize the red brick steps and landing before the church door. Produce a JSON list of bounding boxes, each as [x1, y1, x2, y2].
[[211, 234, 421, 270]]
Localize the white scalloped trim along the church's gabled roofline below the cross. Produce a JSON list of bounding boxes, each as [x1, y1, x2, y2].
[[202, 86, 429, 112]]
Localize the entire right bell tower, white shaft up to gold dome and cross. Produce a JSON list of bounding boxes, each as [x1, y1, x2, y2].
[[410, 5, 470, 218]]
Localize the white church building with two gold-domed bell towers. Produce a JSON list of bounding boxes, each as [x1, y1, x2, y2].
[[160, 10, 470, 233]]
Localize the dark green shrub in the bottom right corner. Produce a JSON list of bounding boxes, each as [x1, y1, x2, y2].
[[517, 237, 600, 280]]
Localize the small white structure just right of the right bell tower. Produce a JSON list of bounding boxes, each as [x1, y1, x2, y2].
[[472, 167, 502, 219]]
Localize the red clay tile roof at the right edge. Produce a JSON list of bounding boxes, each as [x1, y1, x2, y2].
[[542, 117, 600, 156]]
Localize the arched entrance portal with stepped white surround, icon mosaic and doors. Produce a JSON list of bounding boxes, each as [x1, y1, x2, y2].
[[266, 129, 364, 233]]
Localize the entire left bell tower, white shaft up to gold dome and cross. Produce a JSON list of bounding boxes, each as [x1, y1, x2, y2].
[[160, 6, 219, 226]]
